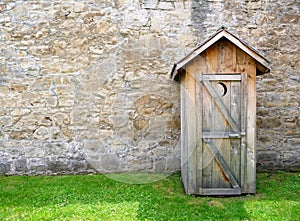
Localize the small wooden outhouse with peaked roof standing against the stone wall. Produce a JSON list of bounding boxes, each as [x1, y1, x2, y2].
[[171, 28, 270, 195]]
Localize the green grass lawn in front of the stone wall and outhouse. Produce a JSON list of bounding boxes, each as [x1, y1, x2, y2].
[[0, 173, 300, 221]]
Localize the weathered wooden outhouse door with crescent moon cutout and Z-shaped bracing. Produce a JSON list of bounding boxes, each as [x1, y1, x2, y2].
[[198, 74, 247, 195]]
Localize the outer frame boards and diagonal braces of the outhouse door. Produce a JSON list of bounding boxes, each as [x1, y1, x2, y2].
[[197, 73, 247, 195]]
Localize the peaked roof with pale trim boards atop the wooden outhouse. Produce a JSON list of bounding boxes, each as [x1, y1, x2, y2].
[[171, 27, 270, 80]]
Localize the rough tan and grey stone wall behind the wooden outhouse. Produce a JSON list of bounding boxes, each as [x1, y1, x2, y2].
[[0, 0, 300, 174]]
